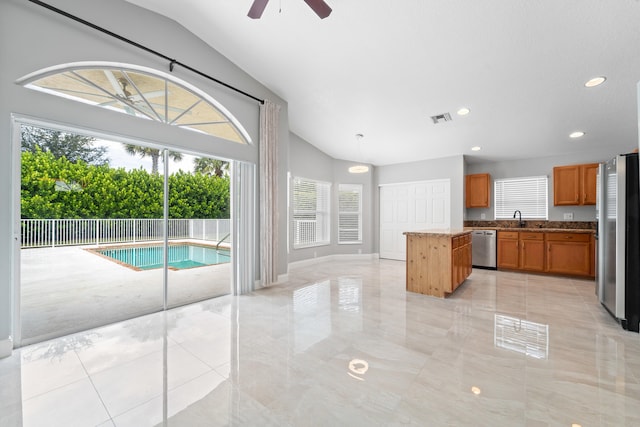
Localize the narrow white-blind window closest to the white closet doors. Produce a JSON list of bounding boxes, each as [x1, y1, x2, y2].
[[338, 184, 362, 244]]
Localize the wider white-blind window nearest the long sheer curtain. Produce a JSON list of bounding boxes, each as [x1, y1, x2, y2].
[[292, 178, 331, 248]]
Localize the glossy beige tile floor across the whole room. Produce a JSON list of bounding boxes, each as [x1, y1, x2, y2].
[[0, 260, 640, 427]]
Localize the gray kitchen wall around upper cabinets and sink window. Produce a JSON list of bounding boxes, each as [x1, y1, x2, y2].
[[465, 152, 618, 221]]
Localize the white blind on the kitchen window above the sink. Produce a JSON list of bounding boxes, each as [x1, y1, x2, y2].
[[494, 176, 549, 219]]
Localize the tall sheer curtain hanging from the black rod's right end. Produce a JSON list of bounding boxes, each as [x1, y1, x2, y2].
[[260, 100, 280, 286]]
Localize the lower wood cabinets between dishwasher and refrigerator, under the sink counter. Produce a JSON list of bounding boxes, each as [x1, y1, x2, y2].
[[497, 231, 595, 277]]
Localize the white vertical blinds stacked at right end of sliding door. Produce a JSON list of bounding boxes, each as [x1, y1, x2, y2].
[[231, 162, 256, 295]]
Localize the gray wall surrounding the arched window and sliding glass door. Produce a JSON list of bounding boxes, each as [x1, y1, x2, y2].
[[0, 0, 289, 356]]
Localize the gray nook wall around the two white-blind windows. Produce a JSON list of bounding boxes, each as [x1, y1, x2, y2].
[[288, 133, 374, 262]]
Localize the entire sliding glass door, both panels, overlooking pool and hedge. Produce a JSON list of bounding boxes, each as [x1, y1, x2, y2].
[[18, 125, 231, 345]]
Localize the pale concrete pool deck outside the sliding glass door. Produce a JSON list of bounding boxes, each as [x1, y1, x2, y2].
[[20, 242, 231, 344]]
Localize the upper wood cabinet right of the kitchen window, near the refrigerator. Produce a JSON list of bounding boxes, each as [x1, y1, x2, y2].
[[553, 163, 598, 206]]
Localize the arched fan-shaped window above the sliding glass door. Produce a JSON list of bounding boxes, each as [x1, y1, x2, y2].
[[18, 62, 251, 144]]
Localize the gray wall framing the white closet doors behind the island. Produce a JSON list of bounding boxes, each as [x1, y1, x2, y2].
[[373, 155, 465, 252]]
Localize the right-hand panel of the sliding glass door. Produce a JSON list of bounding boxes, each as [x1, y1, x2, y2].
[[167, 152, 231, 307]]
